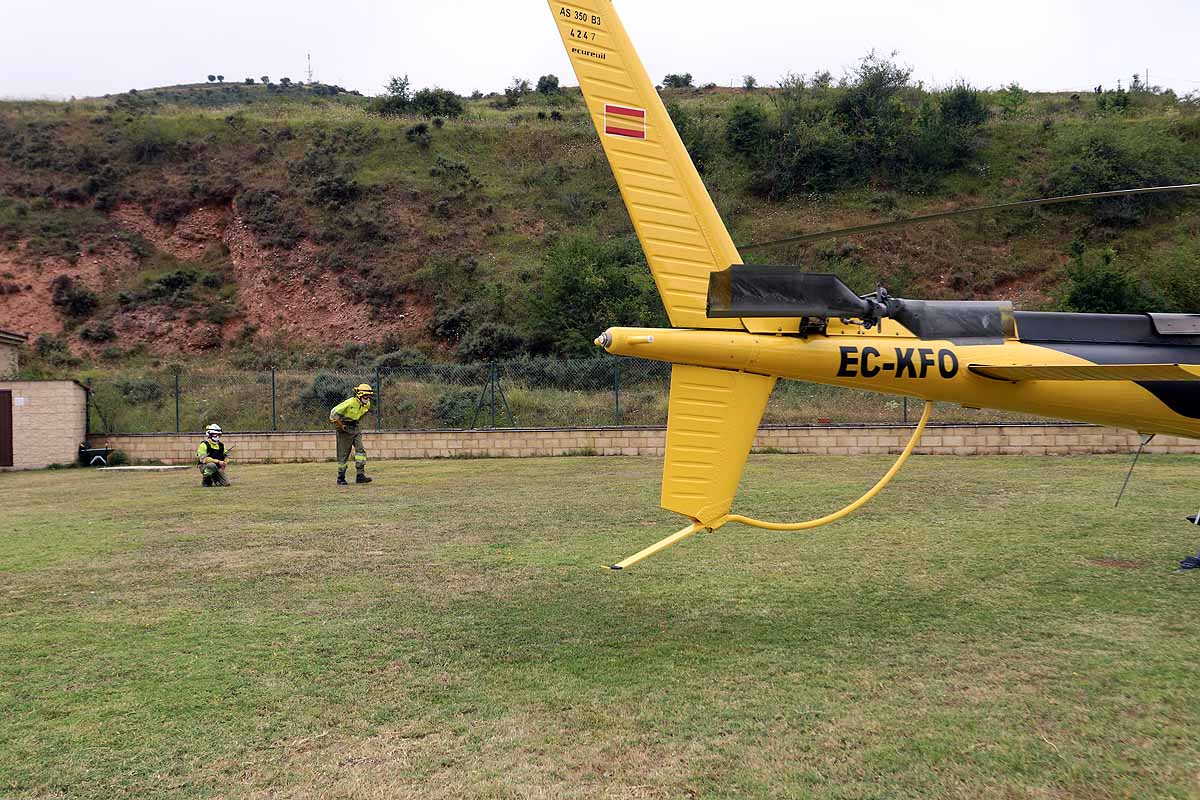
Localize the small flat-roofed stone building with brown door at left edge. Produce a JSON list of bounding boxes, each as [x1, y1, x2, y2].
[[0, 380, 88, 470]]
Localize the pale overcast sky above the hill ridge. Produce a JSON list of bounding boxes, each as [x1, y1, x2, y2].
[[0, 0, 1200, 98]]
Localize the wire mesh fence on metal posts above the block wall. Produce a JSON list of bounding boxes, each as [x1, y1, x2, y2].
[[89, 356, 1060, 433]]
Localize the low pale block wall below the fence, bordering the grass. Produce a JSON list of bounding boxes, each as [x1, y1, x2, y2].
[[92, 425, 1200, 464]]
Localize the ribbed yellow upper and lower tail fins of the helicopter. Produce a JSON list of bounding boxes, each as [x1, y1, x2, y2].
[[550, 0, 796, 544]]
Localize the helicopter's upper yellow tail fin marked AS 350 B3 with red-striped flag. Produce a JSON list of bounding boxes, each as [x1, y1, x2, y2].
[[550, 0, 743, 330]]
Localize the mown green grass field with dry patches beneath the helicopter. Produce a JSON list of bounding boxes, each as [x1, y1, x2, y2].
[[0, 456, 1200, 799]]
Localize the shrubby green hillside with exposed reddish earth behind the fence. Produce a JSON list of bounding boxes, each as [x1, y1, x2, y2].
[[0, 66, 1200, 379]]
